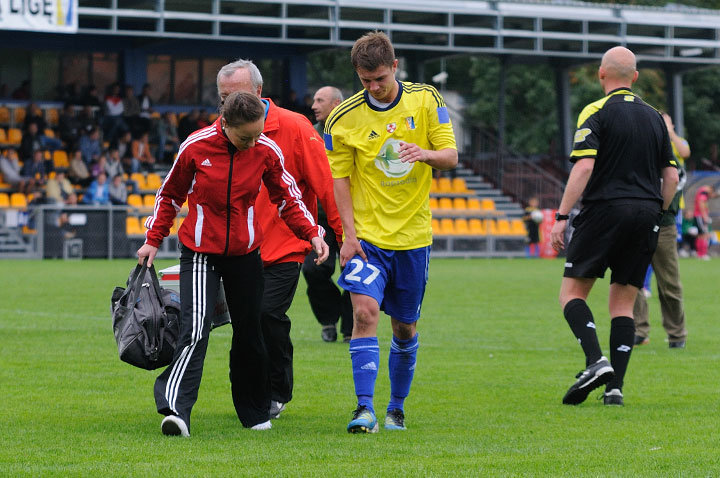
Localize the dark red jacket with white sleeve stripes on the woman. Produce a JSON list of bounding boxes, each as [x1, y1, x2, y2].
[[145, 118, 325, 256]]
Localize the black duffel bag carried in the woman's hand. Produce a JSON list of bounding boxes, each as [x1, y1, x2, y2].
[[110, 258, 180, 370]]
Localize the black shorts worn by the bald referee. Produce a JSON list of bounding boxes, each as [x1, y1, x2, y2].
[[564, 201, 660, 288]]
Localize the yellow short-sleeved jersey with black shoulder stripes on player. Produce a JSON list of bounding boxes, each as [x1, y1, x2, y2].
[[323, 82, 456, 250]]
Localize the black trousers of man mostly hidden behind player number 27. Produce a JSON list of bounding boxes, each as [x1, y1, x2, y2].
[[302, 219, 352, 336]]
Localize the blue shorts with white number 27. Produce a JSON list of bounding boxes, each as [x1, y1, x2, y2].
[[338, 240, 430, 324]]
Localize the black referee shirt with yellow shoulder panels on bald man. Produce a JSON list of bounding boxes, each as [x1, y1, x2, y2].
[[570, 88, 677, 203]]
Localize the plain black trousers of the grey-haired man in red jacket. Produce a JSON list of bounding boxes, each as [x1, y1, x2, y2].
[[262, 262, 300, 403]]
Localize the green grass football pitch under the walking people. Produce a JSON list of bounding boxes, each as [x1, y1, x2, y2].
[[0, 259, 720, 477]]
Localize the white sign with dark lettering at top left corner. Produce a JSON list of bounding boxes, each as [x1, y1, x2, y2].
[[0, 0, 78, 33]]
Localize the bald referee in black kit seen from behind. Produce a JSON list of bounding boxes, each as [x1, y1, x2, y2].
[[552, 46, 678, 405]]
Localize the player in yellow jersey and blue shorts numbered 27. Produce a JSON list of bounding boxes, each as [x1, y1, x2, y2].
[[324, 31, 457, 433]]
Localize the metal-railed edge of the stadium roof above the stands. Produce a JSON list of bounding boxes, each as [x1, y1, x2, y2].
[[78, 0, 720, 66]]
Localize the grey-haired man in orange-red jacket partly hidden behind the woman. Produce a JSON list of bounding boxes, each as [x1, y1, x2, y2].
[[217, 60, 342, 418]]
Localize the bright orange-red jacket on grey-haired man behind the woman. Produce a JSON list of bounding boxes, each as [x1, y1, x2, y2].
[[256, 98, 342, 265]]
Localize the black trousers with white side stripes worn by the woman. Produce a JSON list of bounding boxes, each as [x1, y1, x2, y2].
[[155, 246, 270, 429]]
